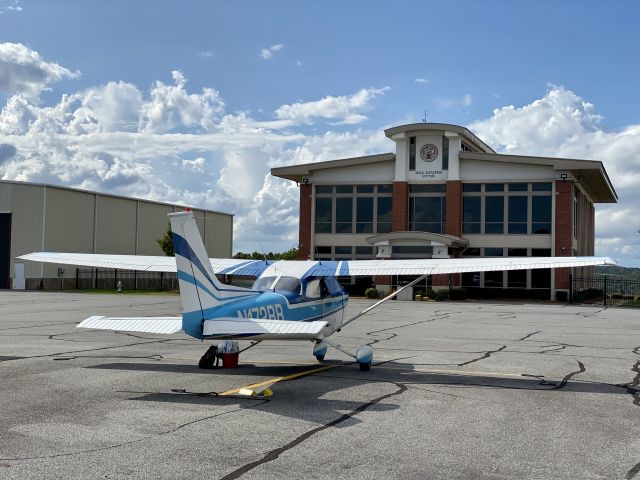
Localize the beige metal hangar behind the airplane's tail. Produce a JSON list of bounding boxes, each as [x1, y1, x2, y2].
[[0, 180, 233, 289]]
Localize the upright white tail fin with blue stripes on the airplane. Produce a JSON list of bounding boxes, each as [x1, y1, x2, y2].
[[169, 210, 259, 338]]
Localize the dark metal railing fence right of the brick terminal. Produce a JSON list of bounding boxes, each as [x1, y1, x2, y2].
[[569, 275, 640, 308]]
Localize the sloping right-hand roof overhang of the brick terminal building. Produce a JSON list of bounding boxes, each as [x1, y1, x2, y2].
[[460, 152, 618, 203]]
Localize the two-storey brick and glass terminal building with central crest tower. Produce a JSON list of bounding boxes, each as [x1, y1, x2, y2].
[[271, 123, 617, 298]]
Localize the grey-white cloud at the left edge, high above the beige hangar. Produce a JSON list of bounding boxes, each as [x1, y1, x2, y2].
[[0, 42, 79, 97]]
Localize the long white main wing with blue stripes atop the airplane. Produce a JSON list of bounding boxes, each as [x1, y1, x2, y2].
[[18, 252, 616, 278]]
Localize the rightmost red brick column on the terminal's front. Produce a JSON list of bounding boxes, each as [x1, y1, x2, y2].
[[553, 180, 572, 290]]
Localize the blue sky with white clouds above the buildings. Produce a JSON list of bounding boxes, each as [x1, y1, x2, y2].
[[0, 0, 640, 267]]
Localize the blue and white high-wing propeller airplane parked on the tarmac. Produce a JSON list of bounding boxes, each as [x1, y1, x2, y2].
[[18, 209, 616, 370]]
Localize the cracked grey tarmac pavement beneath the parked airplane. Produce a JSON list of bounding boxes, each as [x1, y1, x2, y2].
[[0, 291, 640, 479]]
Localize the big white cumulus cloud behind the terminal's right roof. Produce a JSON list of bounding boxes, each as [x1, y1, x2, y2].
[[468, 86, 640, 266]]
